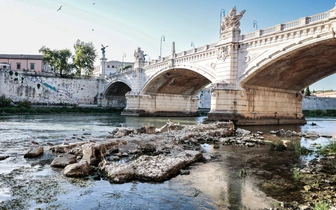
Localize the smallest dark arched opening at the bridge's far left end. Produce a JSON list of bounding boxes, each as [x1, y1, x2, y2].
[[104, 82, 131, 108]]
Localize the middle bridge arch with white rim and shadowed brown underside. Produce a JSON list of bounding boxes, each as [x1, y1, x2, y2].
[[141, 64, 215, 96]]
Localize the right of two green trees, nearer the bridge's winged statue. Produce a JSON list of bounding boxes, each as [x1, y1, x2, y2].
[[73, 39, 97, 76]]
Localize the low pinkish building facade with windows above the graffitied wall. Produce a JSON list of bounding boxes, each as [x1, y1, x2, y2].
[[0, 54, 45, 72]]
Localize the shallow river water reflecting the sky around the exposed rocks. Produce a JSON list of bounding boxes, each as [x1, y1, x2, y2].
[[0, 114, 336, 209]]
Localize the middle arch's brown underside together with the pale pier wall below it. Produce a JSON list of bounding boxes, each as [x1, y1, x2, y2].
[[122, 67, 212, 116]]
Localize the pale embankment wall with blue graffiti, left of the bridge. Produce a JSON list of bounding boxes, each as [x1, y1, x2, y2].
[[0, 70, 98, 104]]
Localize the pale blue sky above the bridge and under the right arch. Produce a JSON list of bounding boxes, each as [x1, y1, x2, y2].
[[0, 0, 336, 90]]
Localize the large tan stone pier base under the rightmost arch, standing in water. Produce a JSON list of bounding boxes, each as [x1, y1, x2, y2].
[[208, 87, 306, 125]]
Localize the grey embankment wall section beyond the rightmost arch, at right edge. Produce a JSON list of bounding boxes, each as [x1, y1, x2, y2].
[[302, 96, 336, 110]]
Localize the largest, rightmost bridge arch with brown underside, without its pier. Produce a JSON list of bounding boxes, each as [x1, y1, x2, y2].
[[239, 37, 336, 92]]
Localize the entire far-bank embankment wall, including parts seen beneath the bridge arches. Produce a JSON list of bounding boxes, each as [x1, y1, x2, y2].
[[0, 70, 336, 110]]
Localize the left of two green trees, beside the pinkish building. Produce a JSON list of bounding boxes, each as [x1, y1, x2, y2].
[[39, 46, 73, 76]]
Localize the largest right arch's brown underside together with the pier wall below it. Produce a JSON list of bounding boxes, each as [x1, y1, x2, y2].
[[232, 39, 336, 124]]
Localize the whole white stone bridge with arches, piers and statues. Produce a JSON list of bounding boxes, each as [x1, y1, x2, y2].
[[99, 7, 336, 125]]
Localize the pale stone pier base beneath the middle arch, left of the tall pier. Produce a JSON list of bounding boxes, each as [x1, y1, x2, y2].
[[121, 92, 199, 117]]
